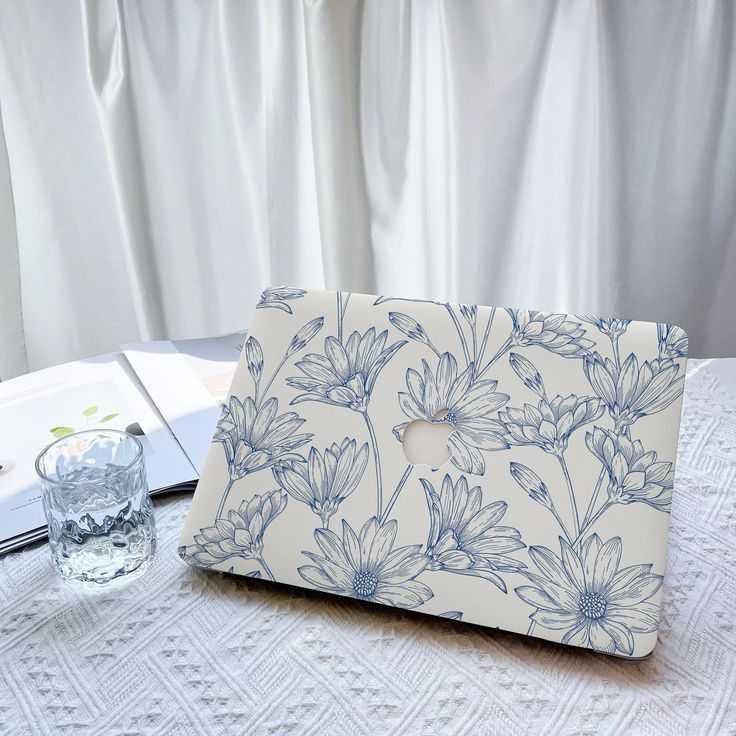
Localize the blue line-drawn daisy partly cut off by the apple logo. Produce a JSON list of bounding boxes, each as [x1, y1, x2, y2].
[[394, 353, 509, 475]]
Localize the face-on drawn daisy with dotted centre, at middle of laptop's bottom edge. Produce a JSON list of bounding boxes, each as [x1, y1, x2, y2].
[[299, 516, 432, 608]]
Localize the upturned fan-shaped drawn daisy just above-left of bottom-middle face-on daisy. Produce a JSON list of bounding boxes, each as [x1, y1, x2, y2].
[[272, 437, 368, 528]]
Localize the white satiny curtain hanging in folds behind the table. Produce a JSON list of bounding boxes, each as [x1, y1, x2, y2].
[[0, 0, 736, 377]]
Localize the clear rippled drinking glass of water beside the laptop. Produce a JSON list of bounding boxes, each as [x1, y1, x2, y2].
[[36, 429, 156, 588]]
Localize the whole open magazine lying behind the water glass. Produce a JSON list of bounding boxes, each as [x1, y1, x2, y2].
[[0, 333, 245, 555]]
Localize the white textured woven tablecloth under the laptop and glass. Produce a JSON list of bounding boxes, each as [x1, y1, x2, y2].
[[0, 360, 736, 736]]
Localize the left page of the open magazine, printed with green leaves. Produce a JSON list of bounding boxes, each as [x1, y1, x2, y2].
[[0, 353, 197, 551]]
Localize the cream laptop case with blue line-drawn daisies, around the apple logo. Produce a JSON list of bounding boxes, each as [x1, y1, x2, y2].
[[179, 287, 688, 658]]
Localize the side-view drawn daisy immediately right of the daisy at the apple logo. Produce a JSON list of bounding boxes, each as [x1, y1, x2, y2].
[[498, 394, 604, 455]]
